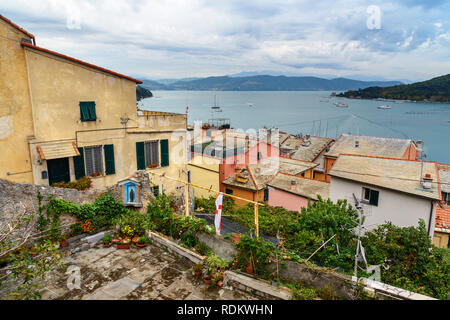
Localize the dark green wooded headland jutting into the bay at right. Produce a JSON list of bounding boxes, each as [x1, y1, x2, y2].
[[339, 74, 450, 102]]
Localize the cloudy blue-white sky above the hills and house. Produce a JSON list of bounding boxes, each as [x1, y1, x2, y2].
[[0, 0, 450, 81]]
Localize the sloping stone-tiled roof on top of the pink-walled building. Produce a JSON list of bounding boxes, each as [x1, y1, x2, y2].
[[267, 173, 330, 200]]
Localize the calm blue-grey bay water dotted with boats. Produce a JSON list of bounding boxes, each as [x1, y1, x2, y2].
[[140, 91, 450, 163]]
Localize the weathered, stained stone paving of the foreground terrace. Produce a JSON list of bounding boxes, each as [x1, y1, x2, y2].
[[41, 244, 257, 300]]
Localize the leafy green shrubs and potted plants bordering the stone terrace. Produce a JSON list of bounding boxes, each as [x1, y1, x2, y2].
[[0, 193, 450, 299]]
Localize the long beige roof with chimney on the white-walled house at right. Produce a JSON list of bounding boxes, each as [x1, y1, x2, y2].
[[330, 154, 441, 200]]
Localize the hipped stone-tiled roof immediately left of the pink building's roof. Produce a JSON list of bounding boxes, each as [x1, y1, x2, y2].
[[223, 161, 278, 191]]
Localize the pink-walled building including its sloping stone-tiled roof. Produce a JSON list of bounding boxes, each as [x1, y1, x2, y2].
[[267, 172, 330, 212]]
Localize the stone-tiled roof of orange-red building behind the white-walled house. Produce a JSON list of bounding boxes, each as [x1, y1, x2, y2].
[[326, 133, 413, 159]]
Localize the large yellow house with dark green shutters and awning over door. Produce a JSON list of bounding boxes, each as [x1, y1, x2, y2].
[[0, 16, 187, 190]]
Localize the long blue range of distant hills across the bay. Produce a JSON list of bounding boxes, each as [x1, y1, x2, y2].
[[144, 75, 401, 91]]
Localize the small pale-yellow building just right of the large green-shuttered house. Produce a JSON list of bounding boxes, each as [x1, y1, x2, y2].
[[188, 155, 221, 198]]
